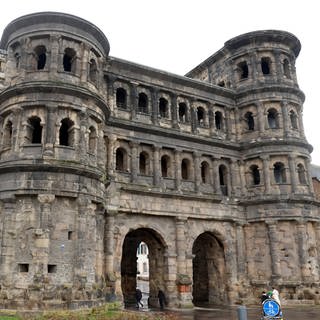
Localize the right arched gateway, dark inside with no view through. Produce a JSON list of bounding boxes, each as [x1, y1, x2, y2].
[[192, 232, 228, 306]]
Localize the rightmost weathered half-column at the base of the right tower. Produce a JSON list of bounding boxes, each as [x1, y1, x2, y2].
[[297, 219, 310, 281]]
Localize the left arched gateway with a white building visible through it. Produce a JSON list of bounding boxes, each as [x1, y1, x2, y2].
[[121, 228, 168, 307]]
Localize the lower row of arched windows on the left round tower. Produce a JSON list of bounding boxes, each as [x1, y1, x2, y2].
[[2, 116, 97, 154]]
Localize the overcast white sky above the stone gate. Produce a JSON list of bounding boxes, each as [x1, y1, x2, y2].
[[0, 0, 320, 165]]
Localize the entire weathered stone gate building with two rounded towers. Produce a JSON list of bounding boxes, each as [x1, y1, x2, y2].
[[0, 12, 320, 308]]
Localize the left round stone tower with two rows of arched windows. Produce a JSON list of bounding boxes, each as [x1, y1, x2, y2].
[[0, 12, 109, 308]]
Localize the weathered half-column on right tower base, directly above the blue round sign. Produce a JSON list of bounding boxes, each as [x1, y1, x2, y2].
[[266, 221, 281, 281]]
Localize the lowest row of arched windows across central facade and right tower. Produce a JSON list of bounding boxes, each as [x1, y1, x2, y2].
[[115, 147, 307, 195]]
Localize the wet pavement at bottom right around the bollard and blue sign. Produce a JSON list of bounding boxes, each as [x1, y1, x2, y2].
[[168, 306, 320, 320]]
